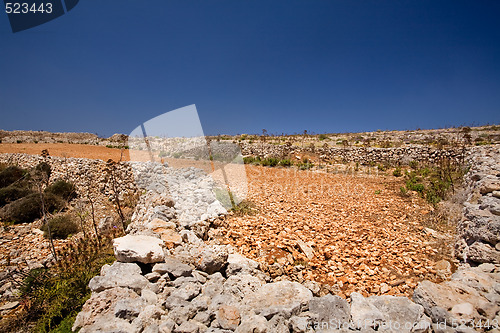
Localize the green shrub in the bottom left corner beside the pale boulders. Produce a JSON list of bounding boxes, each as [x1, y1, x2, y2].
[[14, 238, 115, 332]]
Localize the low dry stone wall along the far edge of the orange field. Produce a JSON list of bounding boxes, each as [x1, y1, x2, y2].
[[241, 143, 470, 165]]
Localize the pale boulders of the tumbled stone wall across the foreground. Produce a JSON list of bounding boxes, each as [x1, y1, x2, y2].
[[73, 147, 500, 332]]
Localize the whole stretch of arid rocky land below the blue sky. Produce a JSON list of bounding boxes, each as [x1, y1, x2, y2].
[[0, 126, 500, 333]]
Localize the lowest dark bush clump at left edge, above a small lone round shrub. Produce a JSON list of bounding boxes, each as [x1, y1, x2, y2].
[[0, 193, 64, 224]]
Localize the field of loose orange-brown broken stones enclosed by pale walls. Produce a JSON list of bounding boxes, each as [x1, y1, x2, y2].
[[213, 166, 447, 296]]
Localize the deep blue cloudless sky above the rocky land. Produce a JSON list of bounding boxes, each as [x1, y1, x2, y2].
[[0, 0, 500, 135]]
